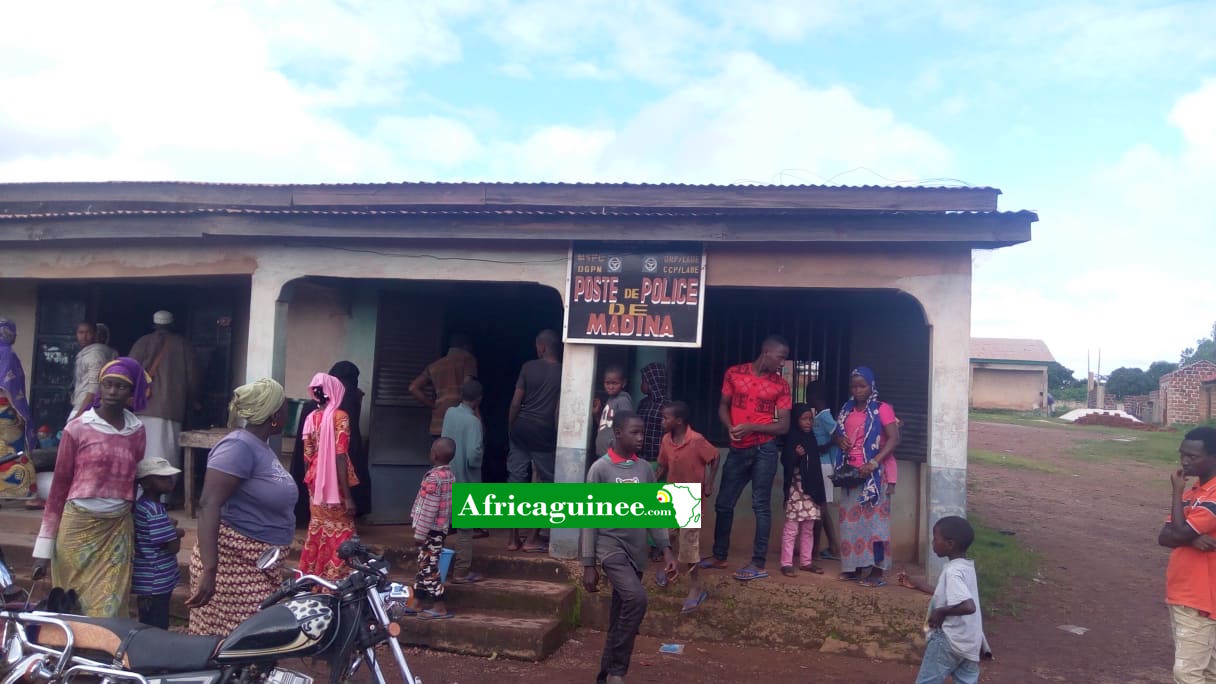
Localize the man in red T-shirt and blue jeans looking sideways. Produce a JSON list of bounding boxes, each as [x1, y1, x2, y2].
[[700, 335, 793, 582]]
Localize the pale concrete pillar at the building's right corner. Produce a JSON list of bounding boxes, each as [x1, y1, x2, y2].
[[905, 273, 972, 582]]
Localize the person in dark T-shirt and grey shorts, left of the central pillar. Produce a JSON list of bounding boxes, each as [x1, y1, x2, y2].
[[507, 330, 562, 553]]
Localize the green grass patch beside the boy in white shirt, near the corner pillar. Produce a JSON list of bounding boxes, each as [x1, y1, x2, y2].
[[967, 514, 1042, 617]]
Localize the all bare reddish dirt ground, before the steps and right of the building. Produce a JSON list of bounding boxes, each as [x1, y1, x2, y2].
[[284, 422, 1172, 684]]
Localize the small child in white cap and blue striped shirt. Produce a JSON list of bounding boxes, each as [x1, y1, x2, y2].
[[131, 456, 186, 629]]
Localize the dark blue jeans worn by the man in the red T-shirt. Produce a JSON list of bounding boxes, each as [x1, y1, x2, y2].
[[714, 439, 781, 568]]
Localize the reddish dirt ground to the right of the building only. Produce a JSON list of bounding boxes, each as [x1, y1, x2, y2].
[[968, 422, 1173, 684]]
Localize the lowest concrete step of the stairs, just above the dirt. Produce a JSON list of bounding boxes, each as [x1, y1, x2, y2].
[[398, 607, 572, 661]]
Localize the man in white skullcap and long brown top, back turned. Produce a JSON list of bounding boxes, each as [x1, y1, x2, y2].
[[130, 310, 198, 494]]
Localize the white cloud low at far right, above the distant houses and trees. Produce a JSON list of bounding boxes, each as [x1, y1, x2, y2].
[[972, 79, 1216, 370]]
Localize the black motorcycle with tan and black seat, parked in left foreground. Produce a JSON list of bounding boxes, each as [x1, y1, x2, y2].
[[0, 538, 422, 684]]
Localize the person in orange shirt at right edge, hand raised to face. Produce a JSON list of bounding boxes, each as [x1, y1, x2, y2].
[[1156, 427, 1216, 684]]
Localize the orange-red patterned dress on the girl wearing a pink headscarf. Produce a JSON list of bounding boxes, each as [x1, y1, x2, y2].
[[300, 410, 359, 582]]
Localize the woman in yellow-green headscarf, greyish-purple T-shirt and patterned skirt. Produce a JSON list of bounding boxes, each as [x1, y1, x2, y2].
[[186, 379, 298, 635]]
